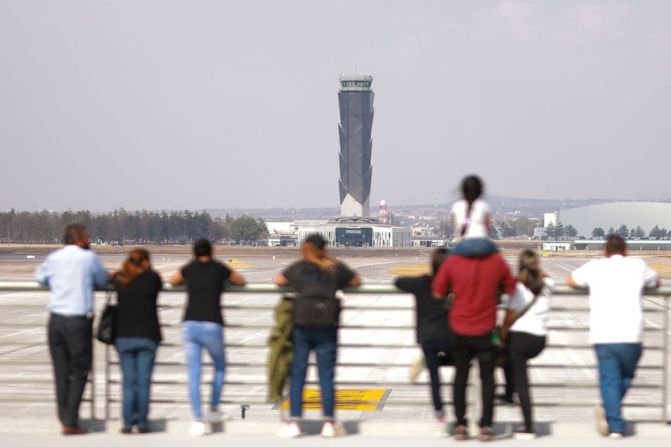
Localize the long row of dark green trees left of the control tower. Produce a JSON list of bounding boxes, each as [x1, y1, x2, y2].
[[0, 209, 268, 244]]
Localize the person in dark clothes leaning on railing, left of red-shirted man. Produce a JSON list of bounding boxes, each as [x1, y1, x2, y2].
[[394, 248, 454, 435]]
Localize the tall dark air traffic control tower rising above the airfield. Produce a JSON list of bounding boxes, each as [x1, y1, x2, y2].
[[338, 75, 375, 217]]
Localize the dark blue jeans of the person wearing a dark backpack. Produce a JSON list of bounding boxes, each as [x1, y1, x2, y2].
[[289, 326, 338, 419]]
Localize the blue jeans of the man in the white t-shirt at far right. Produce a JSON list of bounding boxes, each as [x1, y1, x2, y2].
[[594, 343, 642, 433]]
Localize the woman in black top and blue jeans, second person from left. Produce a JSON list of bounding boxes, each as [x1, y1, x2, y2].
[[114, 248, 162, 433]]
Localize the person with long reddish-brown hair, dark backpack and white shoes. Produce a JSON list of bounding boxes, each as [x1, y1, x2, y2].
[[275, 234, 361, 438]]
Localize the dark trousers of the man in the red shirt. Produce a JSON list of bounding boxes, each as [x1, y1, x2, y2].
[[452, 334, 496, 427]]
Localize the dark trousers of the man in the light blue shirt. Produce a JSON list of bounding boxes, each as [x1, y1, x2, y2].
[[47, 314, 93, 427]]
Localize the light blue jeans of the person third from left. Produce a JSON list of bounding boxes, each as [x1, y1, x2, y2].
[[182, 321, 226, 420]]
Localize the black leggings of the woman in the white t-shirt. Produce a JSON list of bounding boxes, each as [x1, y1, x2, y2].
[[504, 331, 545, 431]]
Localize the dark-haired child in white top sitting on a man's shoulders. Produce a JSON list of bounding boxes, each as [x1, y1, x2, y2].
[[450, 175, 498, 257]]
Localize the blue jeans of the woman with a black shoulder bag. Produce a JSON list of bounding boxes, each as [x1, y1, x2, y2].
[[115, 337, 158, 428]]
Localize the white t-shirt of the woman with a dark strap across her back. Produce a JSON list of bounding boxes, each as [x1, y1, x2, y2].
[[506, 278, 554, 337]]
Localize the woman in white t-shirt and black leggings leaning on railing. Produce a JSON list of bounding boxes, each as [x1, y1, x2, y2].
[[501, 250, 552, 438]]
